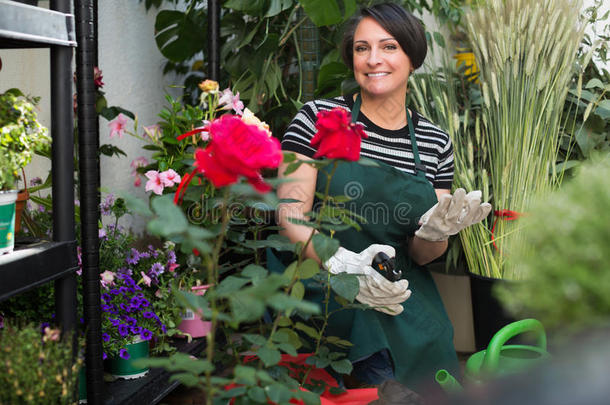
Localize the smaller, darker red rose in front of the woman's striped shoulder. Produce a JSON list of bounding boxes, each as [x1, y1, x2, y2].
[[311, 107, 367, 161]]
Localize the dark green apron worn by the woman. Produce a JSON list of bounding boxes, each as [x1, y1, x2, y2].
[[270, 96, 458, 388]]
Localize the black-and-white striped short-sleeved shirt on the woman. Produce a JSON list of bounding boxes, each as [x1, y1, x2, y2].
[[282, 95, 453, 189]]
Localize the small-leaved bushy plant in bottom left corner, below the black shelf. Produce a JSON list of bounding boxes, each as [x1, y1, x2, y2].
[[0, 323, 83, 404]]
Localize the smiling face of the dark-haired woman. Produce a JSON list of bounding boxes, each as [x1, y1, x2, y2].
[[353, 17, 412, 97]]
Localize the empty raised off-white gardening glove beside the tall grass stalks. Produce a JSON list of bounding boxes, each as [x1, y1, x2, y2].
[[415, 188, 491, 242]]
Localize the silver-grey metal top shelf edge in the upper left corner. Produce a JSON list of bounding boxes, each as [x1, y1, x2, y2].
[[0, 0, 76, 48]]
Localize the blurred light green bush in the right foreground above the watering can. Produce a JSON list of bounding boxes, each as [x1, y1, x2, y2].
[[498, 154, 610, 333]]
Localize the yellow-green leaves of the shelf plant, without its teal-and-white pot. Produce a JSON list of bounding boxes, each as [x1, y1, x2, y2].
[[0, 89, 51, 190]]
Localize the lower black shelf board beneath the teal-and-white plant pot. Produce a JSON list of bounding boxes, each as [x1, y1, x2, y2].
[[0, 241, 78, 301]]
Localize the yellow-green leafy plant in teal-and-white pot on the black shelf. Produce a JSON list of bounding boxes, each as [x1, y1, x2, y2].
[[0, 89, 51, 253]]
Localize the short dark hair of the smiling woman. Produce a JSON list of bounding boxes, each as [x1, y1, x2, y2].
[[341, 3, 428, 70]]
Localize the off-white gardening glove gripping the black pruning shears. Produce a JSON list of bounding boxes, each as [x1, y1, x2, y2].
[[324, 245, 411, 315]]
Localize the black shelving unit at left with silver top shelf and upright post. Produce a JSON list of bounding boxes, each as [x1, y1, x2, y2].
[[0, 0, 77, 329]]
